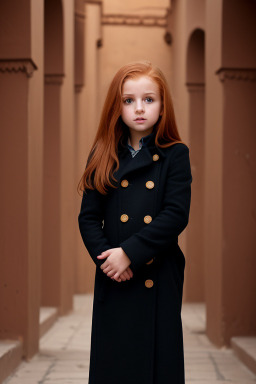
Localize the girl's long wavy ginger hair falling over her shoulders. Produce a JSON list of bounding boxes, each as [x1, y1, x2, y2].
[[78, 61, 182, 194]]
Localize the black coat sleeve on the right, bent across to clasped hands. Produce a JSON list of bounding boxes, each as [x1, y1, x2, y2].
[[120, 144, 192, 270]]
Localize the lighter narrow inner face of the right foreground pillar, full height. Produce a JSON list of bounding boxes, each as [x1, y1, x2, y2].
[[204, 1, 224, 344]]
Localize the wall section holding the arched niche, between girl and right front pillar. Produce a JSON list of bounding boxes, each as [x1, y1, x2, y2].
[[168, 0, 206, 302]]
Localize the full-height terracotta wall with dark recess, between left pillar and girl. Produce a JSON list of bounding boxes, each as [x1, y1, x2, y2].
[[41, 0, 76, 313]]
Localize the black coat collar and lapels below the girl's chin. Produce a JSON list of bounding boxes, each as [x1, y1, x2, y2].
[[114, 135, 166, 181]]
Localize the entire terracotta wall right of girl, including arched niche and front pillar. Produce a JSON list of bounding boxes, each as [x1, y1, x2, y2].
[[169, 0, 256, 345]]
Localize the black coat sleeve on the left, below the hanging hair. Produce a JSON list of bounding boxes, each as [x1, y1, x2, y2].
[[78, 189, 112, 266]]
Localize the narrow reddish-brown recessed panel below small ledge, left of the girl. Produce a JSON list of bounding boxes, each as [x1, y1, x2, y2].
[[41, 74, 64, 308]]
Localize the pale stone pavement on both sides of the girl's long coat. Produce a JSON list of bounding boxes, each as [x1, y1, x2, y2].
[[4, 295, 256, 384]]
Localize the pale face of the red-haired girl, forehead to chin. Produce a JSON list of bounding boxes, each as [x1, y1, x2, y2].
[[121, 76, 162, 136]]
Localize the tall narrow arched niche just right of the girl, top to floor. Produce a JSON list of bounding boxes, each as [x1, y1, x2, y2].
[[185, 29, 205, 302]]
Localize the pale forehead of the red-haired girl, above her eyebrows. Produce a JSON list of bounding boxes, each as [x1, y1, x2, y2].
[[122, 76, 159, 93]]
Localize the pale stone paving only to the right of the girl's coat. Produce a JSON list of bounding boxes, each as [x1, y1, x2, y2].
[[182, 304, 256, 384]]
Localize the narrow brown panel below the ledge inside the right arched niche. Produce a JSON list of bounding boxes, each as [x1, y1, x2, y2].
[[184, 83, 205, 302]]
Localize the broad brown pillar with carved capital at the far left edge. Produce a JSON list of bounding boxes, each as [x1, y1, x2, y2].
[[0, 59, 42, 357]]
